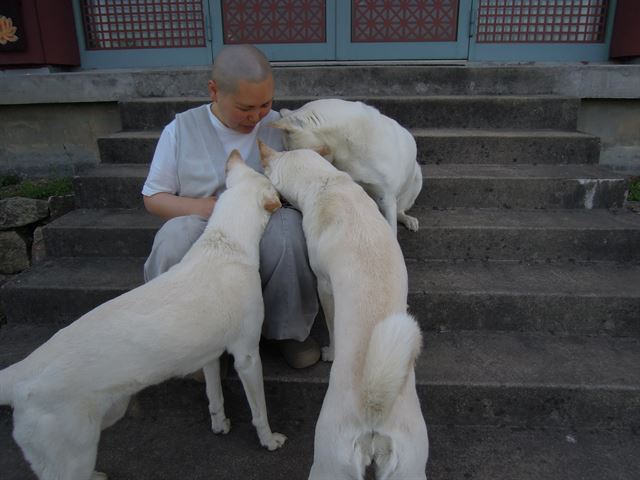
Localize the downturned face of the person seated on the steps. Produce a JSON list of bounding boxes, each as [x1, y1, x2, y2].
[[209, 75, 273, 133]]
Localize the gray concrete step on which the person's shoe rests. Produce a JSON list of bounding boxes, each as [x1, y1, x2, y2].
[[0, 326, 640, 396]]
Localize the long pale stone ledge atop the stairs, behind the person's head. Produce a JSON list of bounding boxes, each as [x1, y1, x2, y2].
[[0, 63, 640, 105]]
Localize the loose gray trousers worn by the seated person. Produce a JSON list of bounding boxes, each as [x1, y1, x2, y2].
[[144, 207, 318, 341]]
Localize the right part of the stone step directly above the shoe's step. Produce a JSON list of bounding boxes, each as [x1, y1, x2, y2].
[[407, 261, 640, 338]]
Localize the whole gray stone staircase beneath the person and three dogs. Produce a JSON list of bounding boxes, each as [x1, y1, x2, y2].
[[0, 69, 640, 480]]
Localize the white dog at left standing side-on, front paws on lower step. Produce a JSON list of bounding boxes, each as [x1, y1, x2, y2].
[[0, 151, 286, 480]]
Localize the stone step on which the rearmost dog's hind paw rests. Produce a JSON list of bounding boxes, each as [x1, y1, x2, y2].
[[44, 207, 640, 262]]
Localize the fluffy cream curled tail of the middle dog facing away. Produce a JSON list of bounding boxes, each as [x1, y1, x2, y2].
[[361, 313, 422, 427]]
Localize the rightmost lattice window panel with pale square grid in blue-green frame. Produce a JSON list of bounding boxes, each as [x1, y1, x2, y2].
[[476, 0, 610, 43]]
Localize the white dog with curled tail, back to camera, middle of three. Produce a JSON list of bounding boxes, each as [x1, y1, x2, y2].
[[260, 144, 429, 480]]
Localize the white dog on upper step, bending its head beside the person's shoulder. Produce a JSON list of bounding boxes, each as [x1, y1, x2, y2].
[[272, 98, 422, 232]]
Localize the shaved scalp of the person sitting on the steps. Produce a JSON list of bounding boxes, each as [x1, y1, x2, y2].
[[211, 45, 271, 93]]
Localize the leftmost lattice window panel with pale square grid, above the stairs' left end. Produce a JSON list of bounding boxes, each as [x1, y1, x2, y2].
[[80, 0, 206, 50]]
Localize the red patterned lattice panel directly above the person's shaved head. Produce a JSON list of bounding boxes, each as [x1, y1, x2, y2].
[[222, 0, 327, 44]]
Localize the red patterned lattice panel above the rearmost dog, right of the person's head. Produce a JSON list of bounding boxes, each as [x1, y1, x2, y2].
[[351, 0, 458, 42]]
